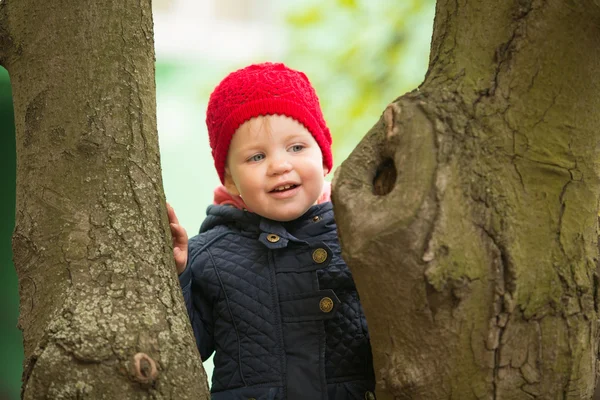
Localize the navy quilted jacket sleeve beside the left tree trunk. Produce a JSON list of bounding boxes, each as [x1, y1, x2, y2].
[[179, 239, 214, 361]]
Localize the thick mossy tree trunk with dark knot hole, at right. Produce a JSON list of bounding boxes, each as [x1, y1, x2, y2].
[[333, 0, 600, 400]]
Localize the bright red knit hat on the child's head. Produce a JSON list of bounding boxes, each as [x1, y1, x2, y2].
[[206, 63, 333, 182]]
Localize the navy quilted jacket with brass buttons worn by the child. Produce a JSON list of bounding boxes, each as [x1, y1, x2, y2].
[[179, 202, 375, 400]]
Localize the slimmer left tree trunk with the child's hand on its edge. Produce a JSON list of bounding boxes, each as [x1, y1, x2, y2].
[[0, 0, 209, 399]]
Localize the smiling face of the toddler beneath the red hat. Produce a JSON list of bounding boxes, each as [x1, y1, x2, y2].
[[225, 115, 328, 221]]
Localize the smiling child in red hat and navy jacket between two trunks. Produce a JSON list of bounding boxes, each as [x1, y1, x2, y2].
[[168, 63, 375, 400]]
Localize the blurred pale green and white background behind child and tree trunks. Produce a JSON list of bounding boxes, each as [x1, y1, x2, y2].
[[0, 0, 435, 400]]
